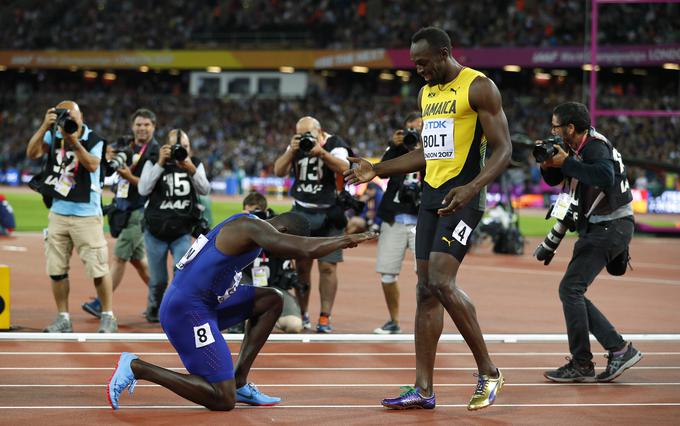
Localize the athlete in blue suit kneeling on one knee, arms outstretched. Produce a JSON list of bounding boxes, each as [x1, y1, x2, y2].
[[107, 213, 376, 411]]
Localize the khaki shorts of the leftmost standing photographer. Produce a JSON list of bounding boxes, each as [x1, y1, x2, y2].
[[45, 212, 109, 278]]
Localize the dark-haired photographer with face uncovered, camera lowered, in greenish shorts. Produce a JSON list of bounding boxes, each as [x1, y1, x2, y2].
[[82, 108, 159, 317]]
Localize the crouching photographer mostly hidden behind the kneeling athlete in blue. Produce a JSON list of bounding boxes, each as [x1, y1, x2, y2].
[[240, 192, 302, 333]]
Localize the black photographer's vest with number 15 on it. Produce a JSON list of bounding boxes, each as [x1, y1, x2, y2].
[[144, 157, 201, 241]]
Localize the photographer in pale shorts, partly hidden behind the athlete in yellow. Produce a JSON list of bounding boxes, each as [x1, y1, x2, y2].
[[373, 112, 423, 334]]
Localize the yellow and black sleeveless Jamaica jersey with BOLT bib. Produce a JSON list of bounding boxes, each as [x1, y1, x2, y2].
[[420, 68, 486, 210]]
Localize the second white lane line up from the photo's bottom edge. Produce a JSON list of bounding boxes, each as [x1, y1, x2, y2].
[[0, 382, 680, 389]]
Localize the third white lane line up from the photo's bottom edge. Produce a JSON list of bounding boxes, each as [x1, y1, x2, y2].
[[0, 365, 680, 372]]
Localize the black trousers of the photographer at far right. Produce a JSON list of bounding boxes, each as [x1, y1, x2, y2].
[[560, 217, 634, 363]]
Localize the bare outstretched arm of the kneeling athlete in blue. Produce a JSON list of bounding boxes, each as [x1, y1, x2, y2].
[[216, 217, 377, 259]]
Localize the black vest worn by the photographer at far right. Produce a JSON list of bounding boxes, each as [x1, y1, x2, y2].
[[576, 127, 633, 228]]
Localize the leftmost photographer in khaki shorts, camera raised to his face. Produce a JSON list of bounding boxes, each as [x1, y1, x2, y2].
[[26, 101, 118, 333]]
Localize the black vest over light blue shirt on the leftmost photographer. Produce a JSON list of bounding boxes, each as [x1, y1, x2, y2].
[[41, 125, 106, 203]]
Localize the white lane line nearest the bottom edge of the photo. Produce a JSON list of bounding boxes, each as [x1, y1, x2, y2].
[[0, 402, 680, 411]]
